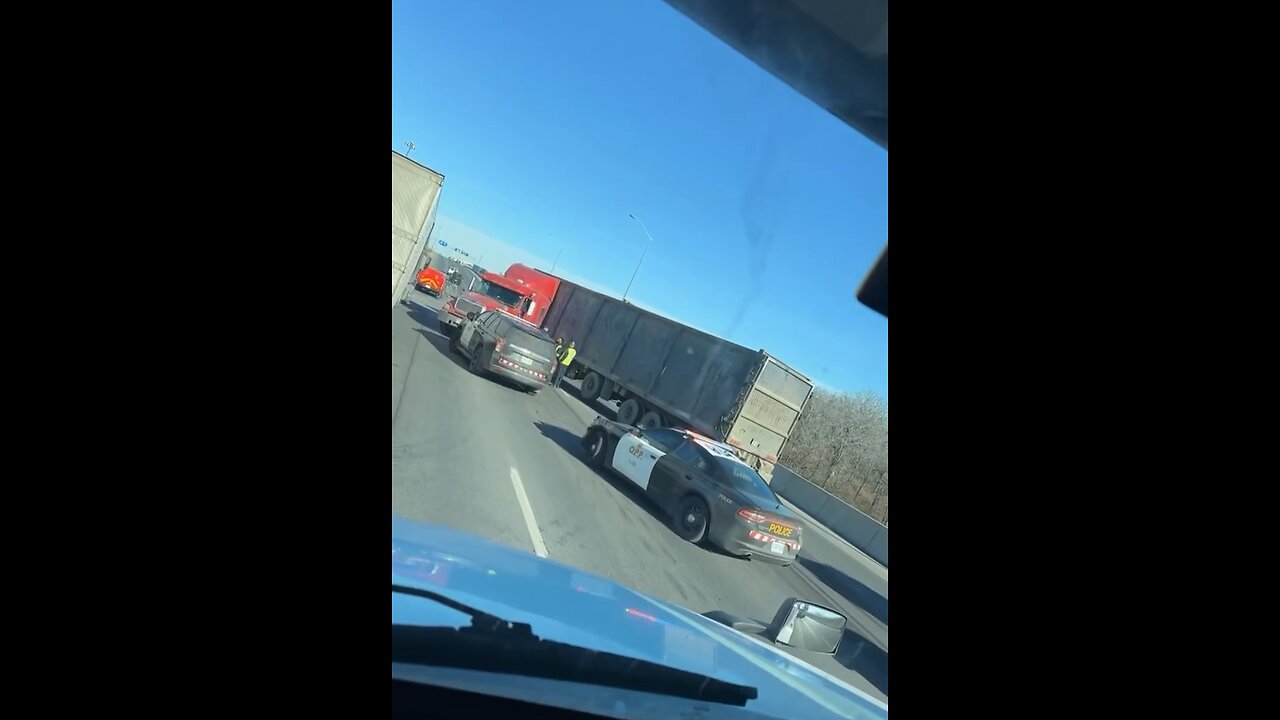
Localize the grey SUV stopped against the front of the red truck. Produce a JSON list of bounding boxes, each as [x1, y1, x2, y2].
[[449, 310, 556, 392]]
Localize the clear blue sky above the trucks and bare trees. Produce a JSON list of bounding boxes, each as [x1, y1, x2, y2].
[[392, 0, 888, 398]]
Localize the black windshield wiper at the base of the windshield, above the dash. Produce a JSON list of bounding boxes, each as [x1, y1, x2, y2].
[[392, 583, 758, 706]]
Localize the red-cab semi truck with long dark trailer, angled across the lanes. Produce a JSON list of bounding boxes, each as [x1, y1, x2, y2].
[[504, 264, 813, 478]]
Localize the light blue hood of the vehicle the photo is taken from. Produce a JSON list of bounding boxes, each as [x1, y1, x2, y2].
[[392, 516, 888, 720]]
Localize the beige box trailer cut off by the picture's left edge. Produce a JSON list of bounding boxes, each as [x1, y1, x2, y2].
[[392, 150, 444, 307]]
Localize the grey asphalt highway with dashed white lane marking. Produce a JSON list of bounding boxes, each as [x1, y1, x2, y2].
[[392, 291, 888, 701]]
